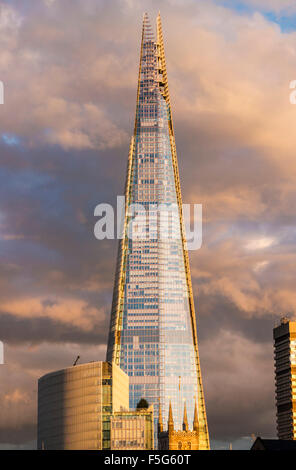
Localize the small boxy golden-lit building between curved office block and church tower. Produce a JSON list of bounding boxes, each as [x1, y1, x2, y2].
[[111, 407, 154, 450]]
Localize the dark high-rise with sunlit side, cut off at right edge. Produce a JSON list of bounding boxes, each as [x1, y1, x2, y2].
[[273, 318, 296, 439]]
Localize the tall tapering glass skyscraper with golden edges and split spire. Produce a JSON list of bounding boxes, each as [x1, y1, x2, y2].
[[107, 14, 209, 449]]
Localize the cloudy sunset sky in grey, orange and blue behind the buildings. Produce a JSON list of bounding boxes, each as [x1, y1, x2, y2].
[[0, 0, 296, 449]]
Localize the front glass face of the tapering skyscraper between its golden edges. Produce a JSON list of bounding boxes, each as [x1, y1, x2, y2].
[[120, 18, 197, 436]]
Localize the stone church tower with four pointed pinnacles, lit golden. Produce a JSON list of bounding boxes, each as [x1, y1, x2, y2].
[[158, 402, 200, 450]]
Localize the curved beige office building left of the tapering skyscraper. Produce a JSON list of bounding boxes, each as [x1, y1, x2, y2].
[[37, 362, 129, 450]]
